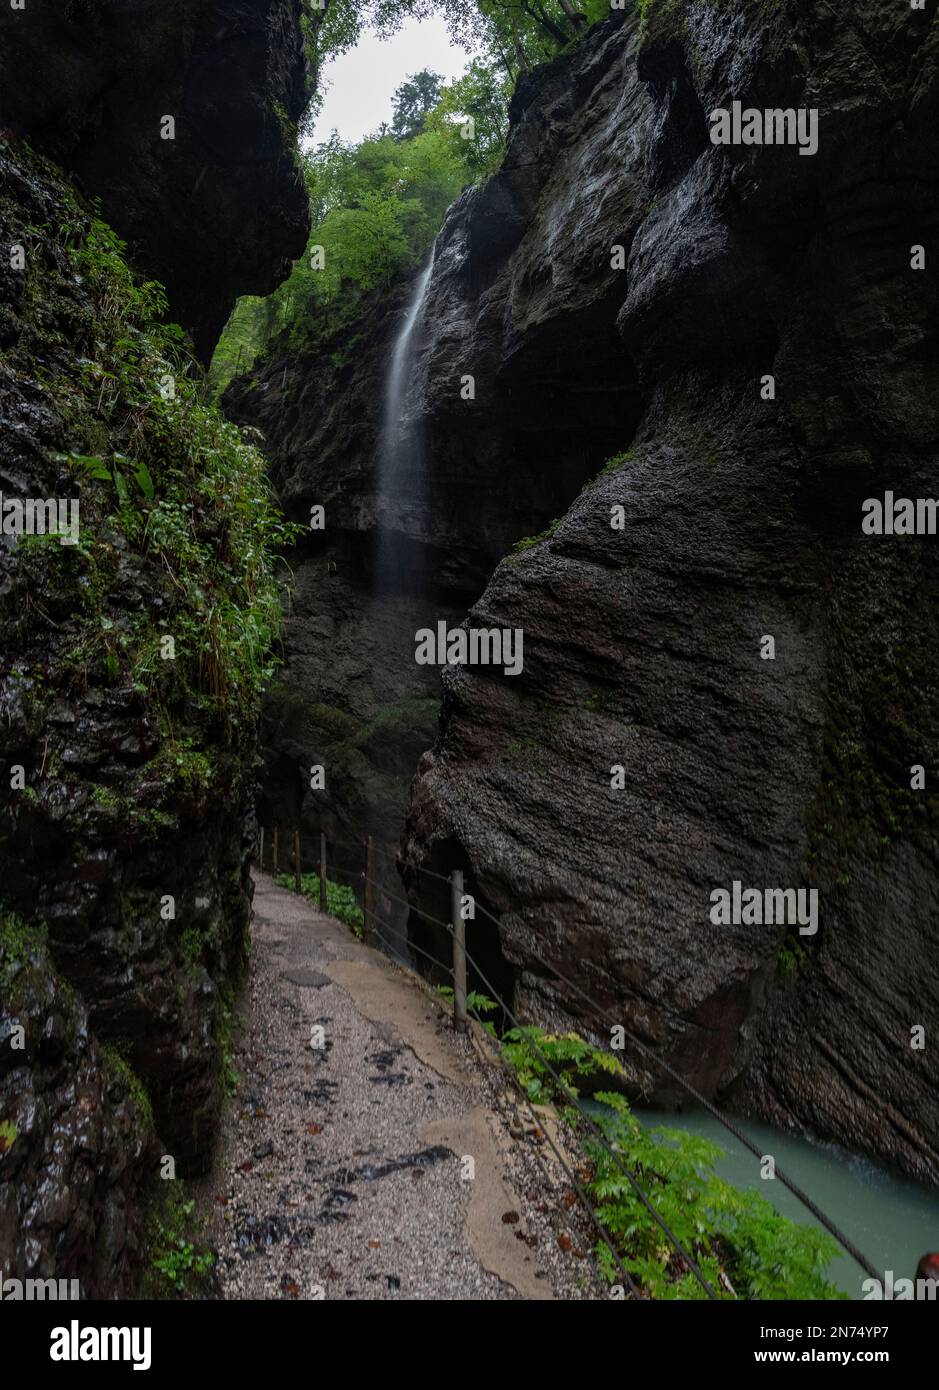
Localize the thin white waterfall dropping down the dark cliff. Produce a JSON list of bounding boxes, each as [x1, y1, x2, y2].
[[375, 256, 433, 592]]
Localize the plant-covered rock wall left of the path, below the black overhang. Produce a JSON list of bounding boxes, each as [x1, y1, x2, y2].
[[0, 142, 293, 1275]]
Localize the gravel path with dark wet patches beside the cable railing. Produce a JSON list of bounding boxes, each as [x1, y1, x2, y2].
[[206, 874, 602, 1300]]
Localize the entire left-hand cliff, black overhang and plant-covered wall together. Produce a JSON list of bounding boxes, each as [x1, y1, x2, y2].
[[0, 0, 307, 1297]]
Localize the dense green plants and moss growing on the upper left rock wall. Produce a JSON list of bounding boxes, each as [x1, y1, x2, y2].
[[9, 154, 299, 741]]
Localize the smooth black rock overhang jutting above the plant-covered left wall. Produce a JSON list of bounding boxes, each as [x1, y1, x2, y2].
[[0, 0, 308, 360]]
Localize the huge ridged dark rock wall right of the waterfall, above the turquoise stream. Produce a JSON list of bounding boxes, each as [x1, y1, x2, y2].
[[406, 0, 939, 1182]]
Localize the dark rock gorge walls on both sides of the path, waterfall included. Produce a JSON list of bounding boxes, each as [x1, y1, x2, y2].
[[0, 0, 939, 1297]]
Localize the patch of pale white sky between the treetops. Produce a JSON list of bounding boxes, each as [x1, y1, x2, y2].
[[313, 15, 470, 145]]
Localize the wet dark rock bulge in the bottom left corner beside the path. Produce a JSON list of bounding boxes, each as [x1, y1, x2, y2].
[[0, 933, 156, 1298]]
